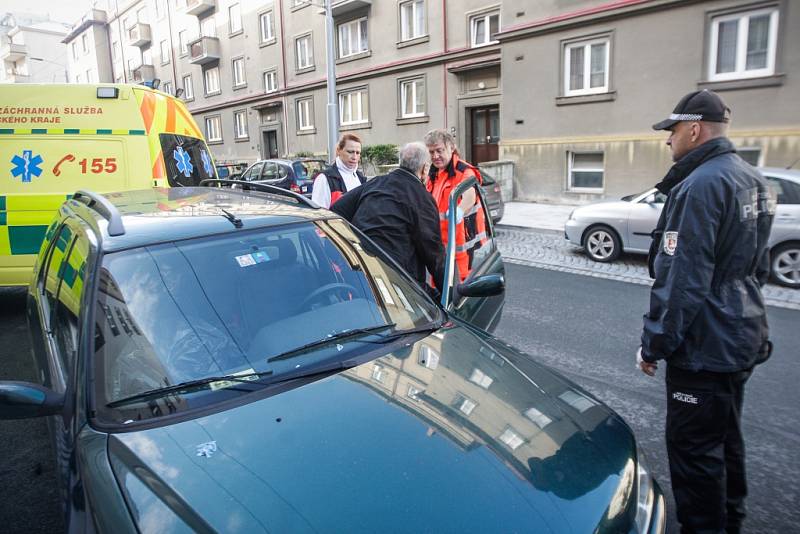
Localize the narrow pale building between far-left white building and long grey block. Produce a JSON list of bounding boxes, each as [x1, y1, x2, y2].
[[61, 9, 113, 83]]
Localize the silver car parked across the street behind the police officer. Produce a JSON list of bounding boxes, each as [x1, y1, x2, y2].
[[565, 167, 800, 288]]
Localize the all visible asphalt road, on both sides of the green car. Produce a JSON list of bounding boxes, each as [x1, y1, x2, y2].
[[0, 264, 800, 533]]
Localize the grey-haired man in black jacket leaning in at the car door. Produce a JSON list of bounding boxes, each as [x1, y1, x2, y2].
[[331, 143, 444, 294]]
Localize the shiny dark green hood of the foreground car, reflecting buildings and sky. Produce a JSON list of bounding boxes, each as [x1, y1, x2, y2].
[[108, 325, 635, 533]]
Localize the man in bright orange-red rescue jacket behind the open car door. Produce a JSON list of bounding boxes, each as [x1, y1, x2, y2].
[[425, 130, 486, 281]]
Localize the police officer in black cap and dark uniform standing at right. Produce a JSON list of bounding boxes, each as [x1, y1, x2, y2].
[[637, 90, 774, 533]]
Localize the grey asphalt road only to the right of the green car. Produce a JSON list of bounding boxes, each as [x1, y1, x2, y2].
[[495, 263, 800, 534]]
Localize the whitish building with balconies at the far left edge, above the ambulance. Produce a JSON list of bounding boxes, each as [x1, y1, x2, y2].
[[0, 13, 69, 83]]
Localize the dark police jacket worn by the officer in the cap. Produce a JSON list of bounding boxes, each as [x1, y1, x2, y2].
[[642, 138, 775, 373]]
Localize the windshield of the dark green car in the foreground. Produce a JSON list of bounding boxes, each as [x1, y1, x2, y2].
[[94, 219, 440, 423]]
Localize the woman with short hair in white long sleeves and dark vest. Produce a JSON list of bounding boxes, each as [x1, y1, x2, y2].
[[311, 134, 367, 208]]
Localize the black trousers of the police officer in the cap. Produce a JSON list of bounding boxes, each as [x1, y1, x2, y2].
[[666, 366, 750, 534]]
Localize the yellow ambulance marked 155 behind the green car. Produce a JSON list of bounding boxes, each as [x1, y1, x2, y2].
[[0, 84, 216, 286]]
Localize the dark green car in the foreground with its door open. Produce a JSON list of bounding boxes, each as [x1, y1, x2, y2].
[[0, 180, 665, 534]]
